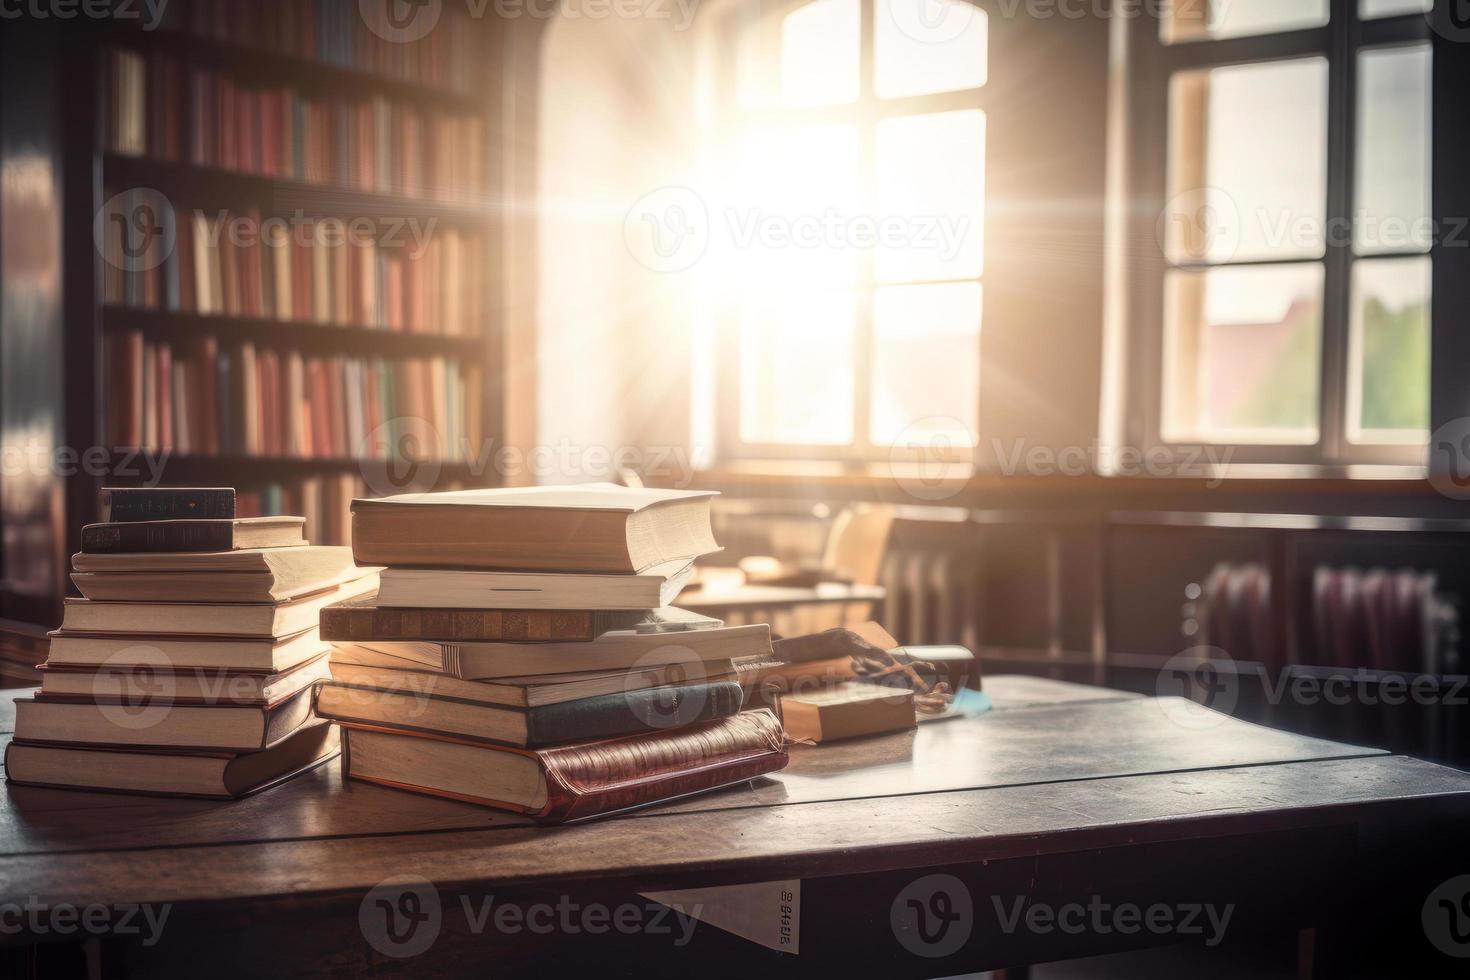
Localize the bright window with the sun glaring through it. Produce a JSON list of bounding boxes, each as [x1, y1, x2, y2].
[[707, 0, 989, 458]]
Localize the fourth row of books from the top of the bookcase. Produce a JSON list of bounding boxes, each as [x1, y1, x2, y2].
[[103, 331, 485, 461]]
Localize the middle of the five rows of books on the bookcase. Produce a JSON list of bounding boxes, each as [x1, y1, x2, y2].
[[103, 196, 488, 336]]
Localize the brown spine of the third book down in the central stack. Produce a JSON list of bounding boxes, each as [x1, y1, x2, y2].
[[322, 605, 595, 642]]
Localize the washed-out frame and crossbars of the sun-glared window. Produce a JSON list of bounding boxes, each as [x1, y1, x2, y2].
[[713, 0, 997, 464]]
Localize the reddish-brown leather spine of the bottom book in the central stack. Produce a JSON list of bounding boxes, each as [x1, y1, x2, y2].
[[534, 711, 788, 823]]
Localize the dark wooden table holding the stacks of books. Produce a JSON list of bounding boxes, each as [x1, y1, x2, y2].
[[0, 677, 1470, 977]]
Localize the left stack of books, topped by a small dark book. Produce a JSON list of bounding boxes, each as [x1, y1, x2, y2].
[[4, 488, 376, 798]]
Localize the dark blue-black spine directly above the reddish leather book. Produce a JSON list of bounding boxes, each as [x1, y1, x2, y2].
[[526, 680, 742, 748]]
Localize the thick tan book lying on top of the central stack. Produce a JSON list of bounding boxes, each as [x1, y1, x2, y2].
[[353, 483, 719, 574]]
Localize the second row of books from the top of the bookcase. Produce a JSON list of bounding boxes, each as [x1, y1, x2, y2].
[[106, 48, 485, 200]]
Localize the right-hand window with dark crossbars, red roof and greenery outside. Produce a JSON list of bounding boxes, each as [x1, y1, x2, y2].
[[1130, 0, 1433, 464]]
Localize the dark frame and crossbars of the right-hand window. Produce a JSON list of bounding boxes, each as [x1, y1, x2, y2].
[[1114, 0, 1439, 467]]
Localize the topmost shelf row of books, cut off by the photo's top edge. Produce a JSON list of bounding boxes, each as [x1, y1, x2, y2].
[[163, 0, 476, 91]]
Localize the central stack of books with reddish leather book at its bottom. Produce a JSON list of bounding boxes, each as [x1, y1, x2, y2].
[[316, 483, 786, 821]]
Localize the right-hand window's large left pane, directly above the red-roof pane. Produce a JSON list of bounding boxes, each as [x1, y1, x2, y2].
[[1164, 57, 1327, 262]]
